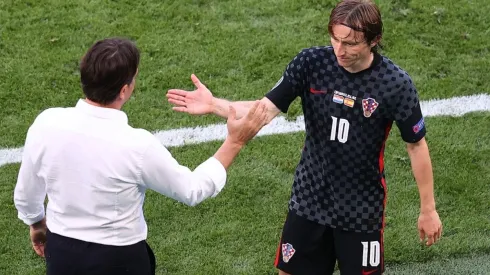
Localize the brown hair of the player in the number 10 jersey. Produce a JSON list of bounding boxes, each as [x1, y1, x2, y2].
[[328, 0, 383, 52]]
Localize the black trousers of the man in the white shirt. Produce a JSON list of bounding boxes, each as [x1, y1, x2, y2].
[[44, 230, 155, 275]]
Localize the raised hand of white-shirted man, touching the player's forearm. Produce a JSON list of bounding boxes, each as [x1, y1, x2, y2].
[[227, 100, 267, 145]]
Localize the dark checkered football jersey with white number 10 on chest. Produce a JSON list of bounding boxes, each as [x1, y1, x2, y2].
[[266, 47, 425, 233]]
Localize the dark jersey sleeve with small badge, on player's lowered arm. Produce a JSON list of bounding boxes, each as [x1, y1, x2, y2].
[[391, 79, 426, 143]]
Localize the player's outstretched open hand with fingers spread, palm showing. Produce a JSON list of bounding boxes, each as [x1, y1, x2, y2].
[[167, 74, 213, 115]]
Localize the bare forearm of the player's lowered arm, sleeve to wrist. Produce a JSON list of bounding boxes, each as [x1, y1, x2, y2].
[[408, 140, 436, 212]]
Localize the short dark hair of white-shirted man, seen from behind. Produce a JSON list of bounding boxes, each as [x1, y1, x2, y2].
[[80, 38, 140, 105]]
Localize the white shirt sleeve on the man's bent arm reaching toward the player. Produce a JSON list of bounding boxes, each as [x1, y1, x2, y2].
[[141, 140, 227, 206]]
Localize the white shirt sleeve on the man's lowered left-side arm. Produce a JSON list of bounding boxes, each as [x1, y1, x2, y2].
[[14, 128, 46, 225]]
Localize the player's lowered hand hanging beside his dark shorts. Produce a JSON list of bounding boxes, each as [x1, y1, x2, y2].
[[418, 210, 442, 246]]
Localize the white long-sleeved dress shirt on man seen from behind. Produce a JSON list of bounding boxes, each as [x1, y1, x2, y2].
[[14, 100, 226, 246]]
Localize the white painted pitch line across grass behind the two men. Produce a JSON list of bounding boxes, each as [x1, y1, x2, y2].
[[0, 94, 490, 167]]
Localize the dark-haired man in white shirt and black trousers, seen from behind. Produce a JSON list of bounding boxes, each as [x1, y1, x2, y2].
[[14, 39, 267, 275]]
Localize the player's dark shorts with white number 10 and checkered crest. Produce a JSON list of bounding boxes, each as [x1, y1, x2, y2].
[[274, 212, 384, 275]]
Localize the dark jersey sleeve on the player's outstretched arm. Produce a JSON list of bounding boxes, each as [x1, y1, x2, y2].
[[265, 49, 308, 113]]
